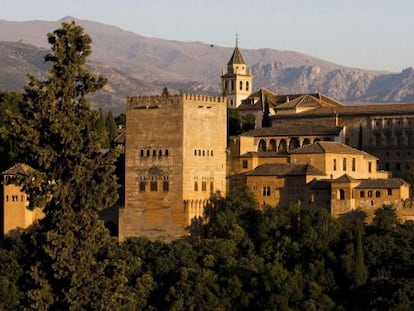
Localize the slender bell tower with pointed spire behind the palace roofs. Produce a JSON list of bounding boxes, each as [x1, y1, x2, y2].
[[221, 39, 253, 108]]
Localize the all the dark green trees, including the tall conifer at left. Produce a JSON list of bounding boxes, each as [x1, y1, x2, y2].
[[0, 23, 414, 310]]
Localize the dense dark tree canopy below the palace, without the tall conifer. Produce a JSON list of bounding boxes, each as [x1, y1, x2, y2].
[[0, 191, 414, 310]]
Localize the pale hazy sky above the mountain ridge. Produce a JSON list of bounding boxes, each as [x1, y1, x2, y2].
[[0, 0, 414, 71]]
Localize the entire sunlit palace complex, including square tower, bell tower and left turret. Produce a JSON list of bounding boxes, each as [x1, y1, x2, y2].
[[2, 42, 414, 241]]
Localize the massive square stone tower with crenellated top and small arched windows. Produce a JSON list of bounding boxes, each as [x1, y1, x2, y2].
[[119, 94, 227, 241]]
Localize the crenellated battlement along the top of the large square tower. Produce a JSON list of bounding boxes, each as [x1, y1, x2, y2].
[[127, 94, 226, 110]]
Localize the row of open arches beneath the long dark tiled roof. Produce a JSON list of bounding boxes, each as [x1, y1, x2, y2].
[[257, 137, 332, 153]]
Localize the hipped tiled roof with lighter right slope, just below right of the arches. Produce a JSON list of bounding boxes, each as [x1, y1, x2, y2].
[[290, 141, 376, 159]]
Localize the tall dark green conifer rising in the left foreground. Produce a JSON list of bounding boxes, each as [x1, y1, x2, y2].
[[6, 22, 133, 310]]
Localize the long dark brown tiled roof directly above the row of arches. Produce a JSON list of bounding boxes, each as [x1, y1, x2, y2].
[[242, 120, 342, 137]]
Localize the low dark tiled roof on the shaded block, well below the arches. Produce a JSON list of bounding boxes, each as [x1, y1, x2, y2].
[[246, 163, 326, 176]]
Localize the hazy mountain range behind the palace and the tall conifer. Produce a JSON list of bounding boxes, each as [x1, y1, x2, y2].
[[0, 17, 414, 114]]
